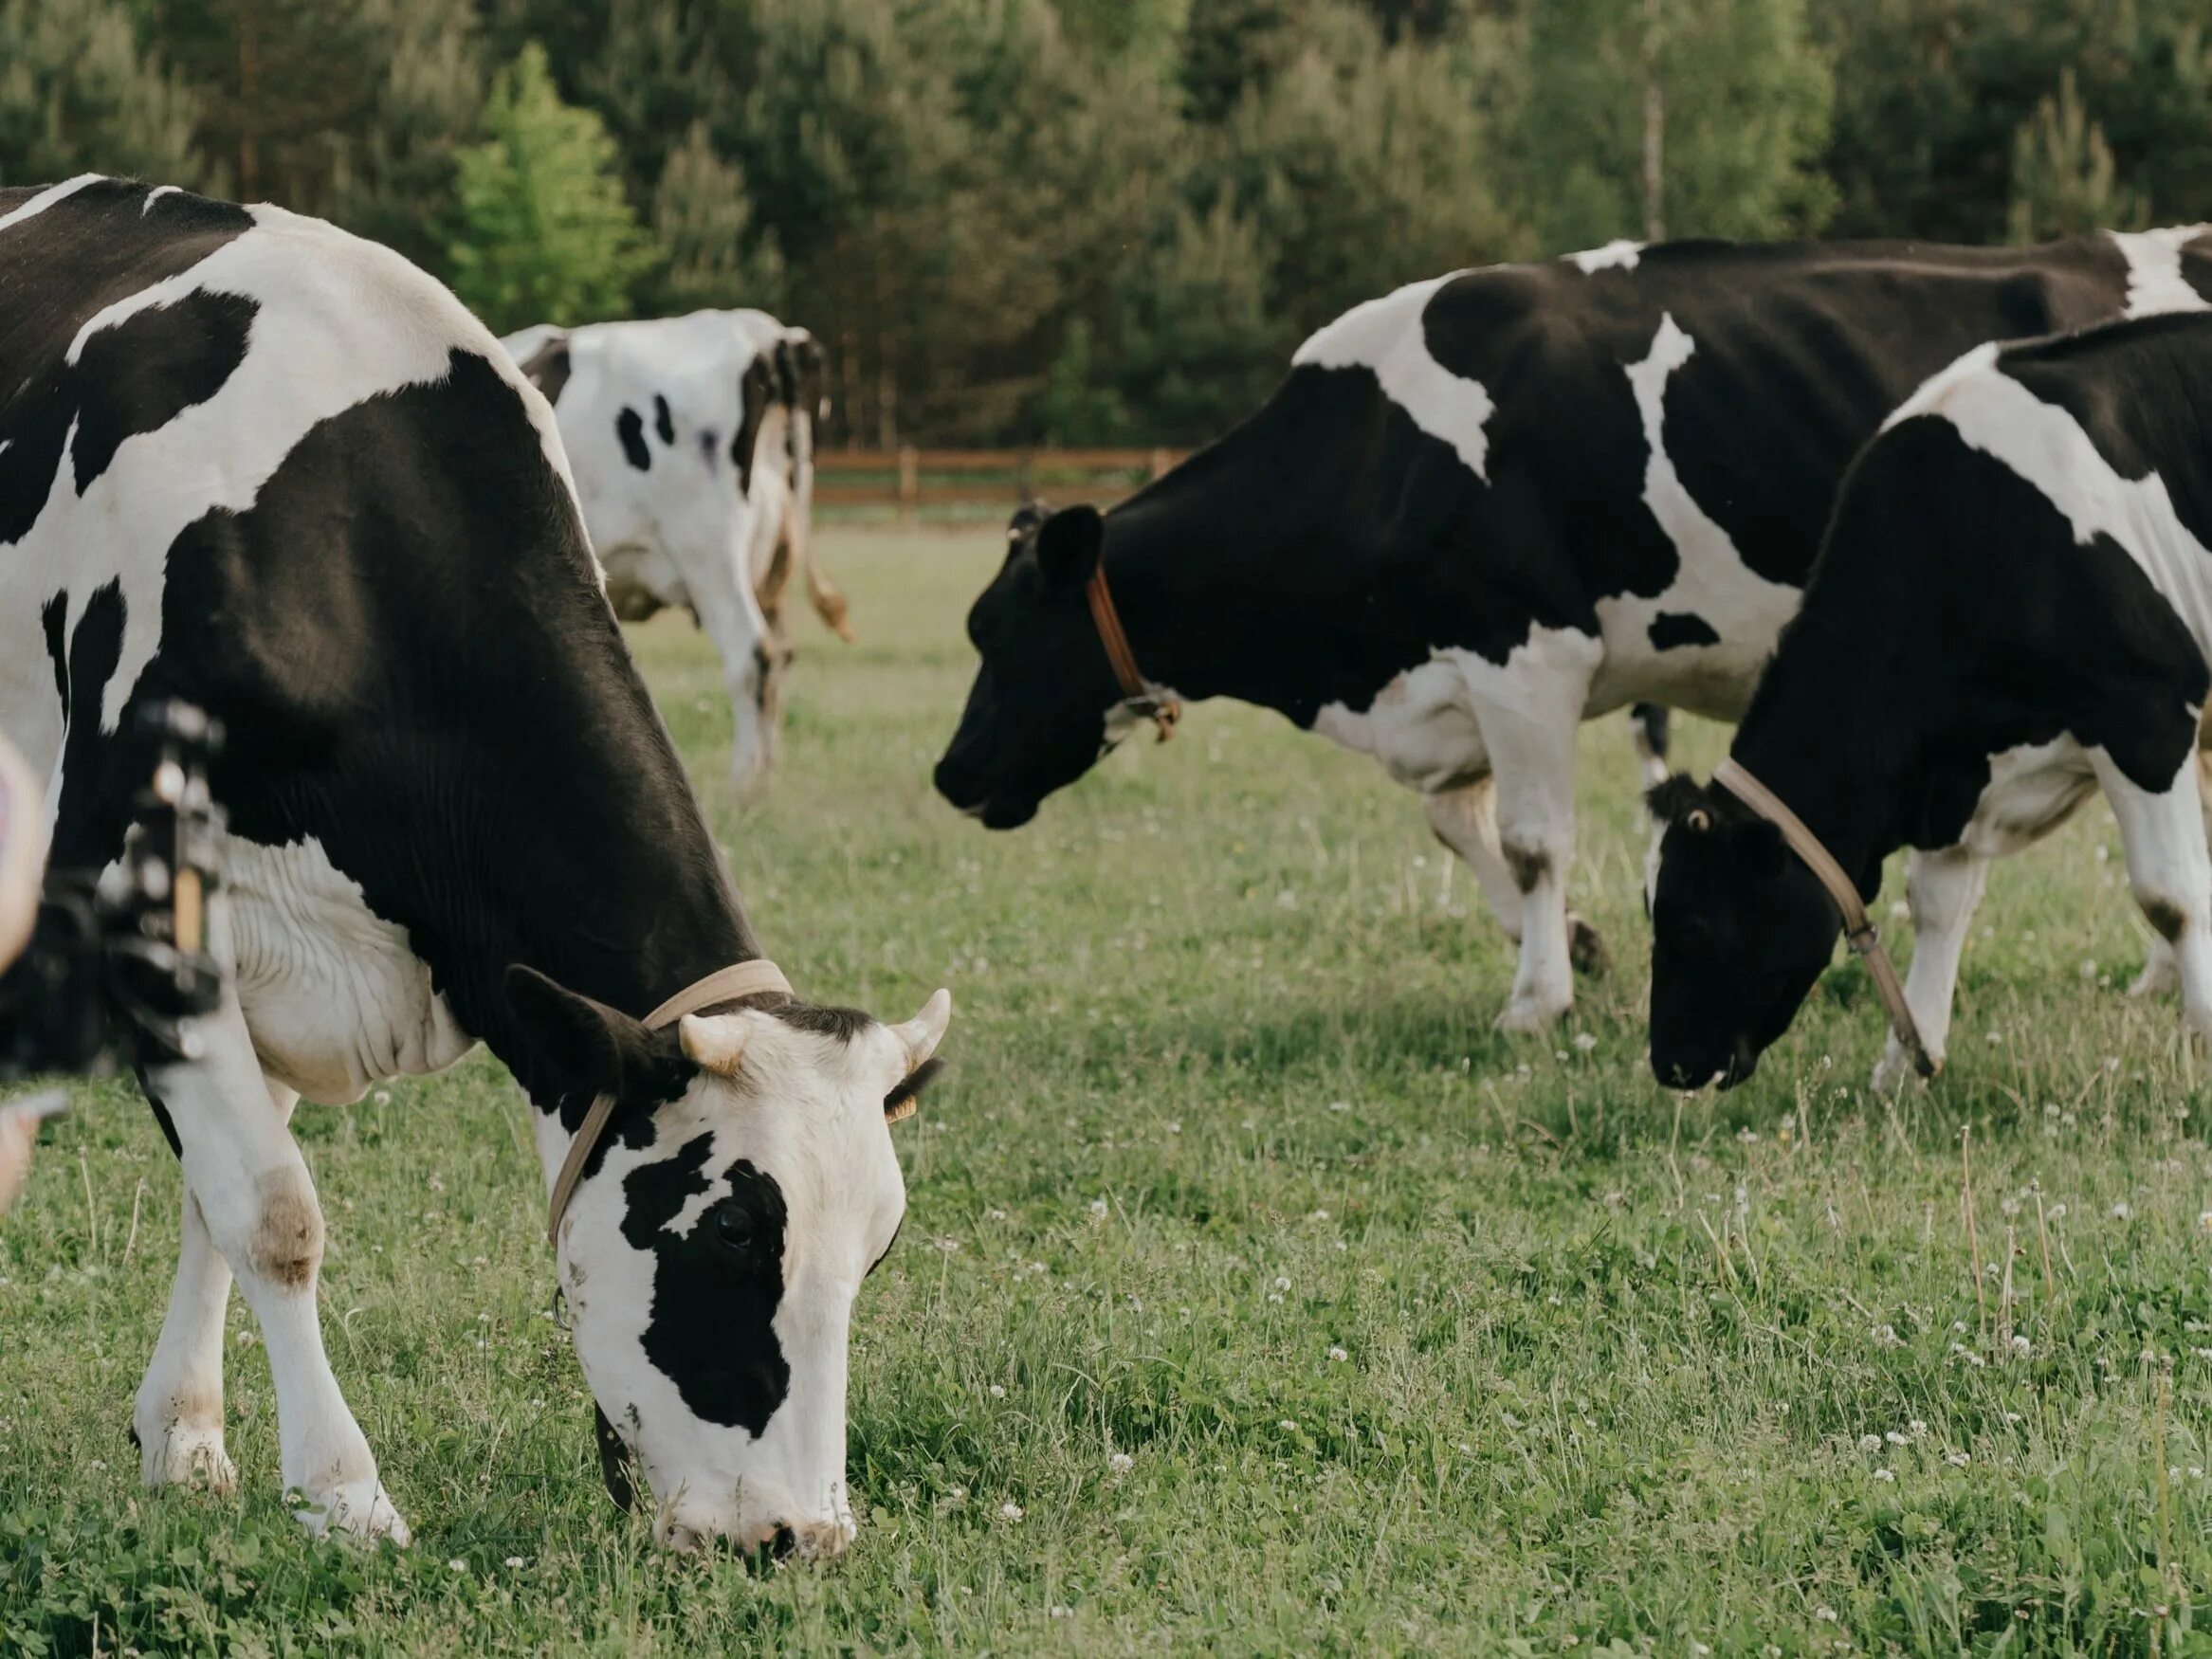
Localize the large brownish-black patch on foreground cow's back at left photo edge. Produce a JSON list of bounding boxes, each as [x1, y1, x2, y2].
[[0, 179, 254, 546]]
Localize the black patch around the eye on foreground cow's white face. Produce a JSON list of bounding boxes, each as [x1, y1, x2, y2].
[[622, 1135, 792, 1435]]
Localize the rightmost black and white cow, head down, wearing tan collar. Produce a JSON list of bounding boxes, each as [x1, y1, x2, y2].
[[1653, 314, 2212, 1084]]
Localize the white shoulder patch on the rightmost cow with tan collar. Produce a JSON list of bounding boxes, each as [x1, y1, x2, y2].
[[1882, 345, 2212, 655]]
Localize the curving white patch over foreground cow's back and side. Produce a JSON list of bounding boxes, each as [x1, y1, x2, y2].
[[0, 186, 573, 752]]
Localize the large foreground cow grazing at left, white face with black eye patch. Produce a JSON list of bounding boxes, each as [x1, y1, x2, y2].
[[0, 177, 951, 1553]]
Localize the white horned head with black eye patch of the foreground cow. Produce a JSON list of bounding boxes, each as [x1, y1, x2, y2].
[[506, 967, 951, 1555]]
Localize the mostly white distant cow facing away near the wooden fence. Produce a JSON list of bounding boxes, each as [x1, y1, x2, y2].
[[503, 312, 851, 801]]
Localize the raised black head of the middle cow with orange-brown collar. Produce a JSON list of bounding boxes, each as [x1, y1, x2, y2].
[[936, 506, 1132, 830]]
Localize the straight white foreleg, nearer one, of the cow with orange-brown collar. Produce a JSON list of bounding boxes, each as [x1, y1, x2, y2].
[[1464, 629, 1603, 1030]]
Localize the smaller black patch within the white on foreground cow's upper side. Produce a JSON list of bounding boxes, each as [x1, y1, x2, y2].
[[71, 290, 261, 496]]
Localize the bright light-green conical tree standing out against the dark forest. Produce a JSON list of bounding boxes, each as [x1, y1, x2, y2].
[[447, 45, 650, 332]]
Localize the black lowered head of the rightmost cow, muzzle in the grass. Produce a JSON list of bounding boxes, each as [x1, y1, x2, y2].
[[1646, 776, 1842, 1088]]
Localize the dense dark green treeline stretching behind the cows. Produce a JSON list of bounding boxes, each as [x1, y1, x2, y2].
[[0, 0, 2212, 445]]
